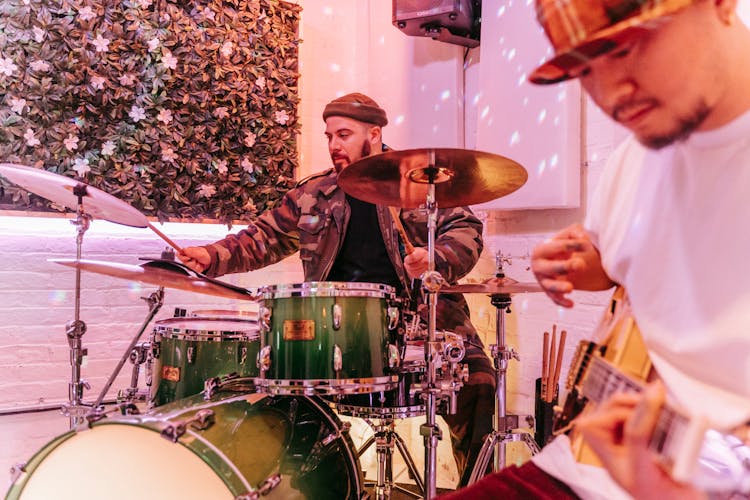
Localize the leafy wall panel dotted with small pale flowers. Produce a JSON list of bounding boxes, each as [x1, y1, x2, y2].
[[0, 0, 300, 222]]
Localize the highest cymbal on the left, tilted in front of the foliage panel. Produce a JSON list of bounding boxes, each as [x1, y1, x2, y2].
[[0, 163, 148, 227]]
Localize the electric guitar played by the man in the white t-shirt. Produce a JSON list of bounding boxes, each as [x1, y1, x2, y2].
[[553, 287, 750, 491]]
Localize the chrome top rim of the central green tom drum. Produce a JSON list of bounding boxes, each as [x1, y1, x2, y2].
[[259, 281, 396, 299]]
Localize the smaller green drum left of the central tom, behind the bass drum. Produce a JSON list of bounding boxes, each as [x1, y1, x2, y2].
[[150, 318, 260, 406]]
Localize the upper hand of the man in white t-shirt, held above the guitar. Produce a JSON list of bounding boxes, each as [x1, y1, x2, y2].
[[531, 224, 615, 307]]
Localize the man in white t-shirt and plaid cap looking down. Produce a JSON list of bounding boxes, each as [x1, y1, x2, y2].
[[530, 0, 750, 498]]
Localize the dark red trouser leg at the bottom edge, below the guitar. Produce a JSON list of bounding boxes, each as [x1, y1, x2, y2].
[[440, 462, 579, 500]]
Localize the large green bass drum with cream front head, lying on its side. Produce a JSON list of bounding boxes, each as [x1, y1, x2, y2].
[[7, 392, 363, 500]]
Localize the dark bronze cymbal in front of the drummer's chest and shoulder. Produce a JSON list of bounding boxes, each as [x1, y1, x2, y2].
[[338, 148, 528, 208]]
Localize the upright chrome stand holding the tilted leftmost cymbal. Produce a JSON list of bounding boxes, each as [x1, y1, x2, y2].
[[61, 183, 92, 429]]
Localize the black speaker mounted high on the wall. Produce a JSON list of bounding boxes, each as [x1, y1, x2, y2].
[[393, 0, 482, 47]]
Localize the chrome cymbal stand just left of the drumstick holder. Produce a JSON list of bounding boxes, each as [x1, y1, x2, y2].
[[468, 252, 539, 484]]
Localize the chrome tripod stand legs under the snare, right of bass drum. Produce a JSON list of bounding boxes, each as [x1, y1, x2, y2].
[[357, 418, 425, 500]]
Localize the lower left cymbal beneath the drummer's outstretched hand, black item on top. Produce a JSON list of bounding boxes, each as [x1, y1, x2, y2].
[[48, 259, 256, 300]]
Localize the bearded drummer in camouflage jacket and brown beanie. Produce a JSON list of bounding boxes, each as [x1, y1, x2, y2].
[[178, 93, 494, 485]]
